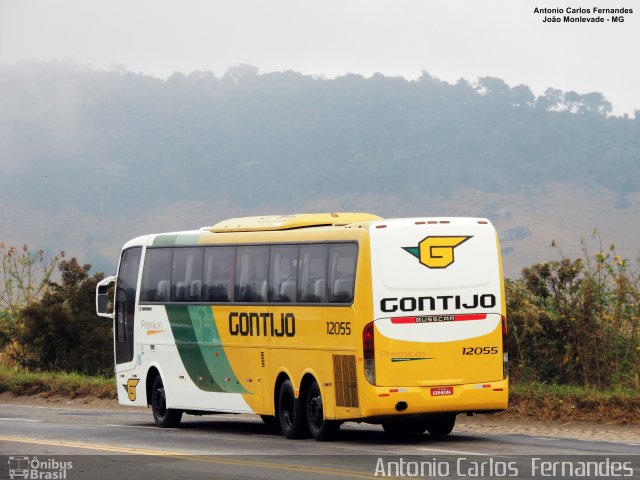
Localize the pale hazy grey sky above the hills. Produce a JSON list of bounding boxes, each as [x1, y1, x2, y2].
[[0, 0, 640, 113]]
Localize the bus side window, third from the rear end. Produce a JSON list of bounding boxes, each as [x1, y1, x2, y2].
[[269, 245, 298, 303]]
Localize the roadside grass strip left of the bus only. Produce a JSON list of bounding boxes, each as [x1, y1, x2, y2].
[[0, 364, 117, 399]]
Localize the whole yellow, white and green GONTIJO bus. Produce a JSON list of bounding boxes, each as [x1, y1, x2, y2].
[[96, 213, 508, 440]]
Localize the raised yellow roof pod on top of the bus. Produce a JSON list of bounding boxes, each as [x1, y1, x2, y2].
[[208, 212, 381, 233]]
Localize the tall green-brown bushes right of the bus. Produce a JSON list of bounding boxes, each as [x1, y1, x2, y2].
[[506, 242, 640, 389]]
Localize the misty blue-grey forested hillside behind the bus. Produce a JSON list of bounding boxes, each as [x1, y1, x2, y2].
[[0, 62, 640, 272]]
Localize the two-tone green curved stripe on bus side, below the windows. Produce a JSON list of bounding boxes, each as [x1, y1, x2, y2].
[[165, 305, 250, 393]]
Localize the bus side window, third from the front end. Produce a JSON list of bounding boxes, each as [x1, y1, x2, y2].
[[202, 247, 236, 302]]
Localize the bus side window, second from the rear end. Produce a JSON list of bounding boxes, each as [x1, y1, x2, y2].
[[298, 245, 329, 303]]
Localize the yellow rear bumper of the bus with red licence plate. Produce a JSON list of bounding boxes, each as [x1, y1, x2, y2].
[[360, 379, 509, 417]]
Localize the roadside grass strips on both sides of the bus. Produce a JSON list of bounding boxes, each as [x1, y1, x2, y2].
[[0, 363, 640, 425]]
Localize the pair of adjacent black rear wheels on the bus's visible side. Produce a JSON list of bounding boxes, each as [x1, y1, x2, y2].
[[278, 379, 340, 441]]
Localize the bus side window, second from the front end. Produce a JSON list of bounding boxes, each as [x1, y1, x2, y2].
[[171, 247, 204, 302]]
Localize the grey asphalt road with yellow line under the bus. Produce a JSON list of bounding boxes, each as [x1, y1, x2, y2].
[[0, 404, 640, 480]]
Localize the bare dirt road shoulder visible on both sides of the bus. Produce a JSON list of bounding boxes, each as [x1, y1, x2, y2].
[[0, 392, 640, 446]]
